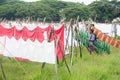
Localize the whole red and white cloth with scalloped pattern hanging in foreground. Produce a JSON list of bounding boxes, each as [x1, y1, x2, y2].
[[0, 25, 64, 64]]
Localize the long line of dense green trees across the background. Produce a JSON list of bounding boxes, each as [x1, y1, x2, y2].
[[0, 0, 120, 22]]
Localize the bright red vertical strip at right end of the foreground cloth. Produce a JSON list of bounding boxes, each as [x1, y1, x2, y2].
[[47, 25, 64, 60]]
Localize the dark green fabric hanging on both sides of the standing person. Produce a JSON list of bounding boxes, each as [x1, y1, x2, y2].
[[74, 30, 110, 54]]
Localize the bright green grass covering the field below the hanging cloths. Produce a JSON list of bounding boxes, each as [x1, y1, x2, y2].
[[0, 47, 120, 80]]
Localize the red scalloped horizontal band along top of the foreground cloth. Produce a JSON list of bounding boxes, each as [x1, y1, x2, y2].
[[0, 25, 52, 42]]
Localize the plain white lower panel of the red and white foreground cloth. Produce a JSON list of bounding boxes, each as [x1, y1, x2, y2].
[[3, 38, 56, 64]]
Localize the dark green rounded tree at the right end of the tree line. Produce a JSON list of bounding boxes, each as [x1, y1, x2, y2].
[[88, 0, 118, 22]]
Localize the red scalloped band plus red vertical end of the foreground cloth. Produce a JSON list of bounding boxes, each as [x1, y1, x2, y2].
[[0, 24, 64, 63]]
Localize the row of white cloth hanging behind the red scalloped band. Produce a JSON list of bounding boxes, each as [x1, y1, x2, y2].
[[0, 21, 60, 28]]
